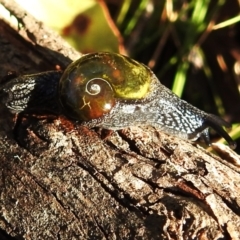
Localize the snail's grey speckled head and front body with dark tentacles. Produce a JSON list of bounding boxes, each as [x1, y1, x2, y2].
[[82, 74, 235, 148]]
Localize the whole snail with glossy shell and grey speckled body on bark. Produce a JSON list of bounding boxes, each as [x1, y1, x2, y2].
[[0, 52, 236, 148]]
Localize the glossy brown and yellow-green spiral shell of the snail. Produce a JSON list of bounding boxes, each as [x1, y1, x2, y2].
[[59, 52, 151, 121]]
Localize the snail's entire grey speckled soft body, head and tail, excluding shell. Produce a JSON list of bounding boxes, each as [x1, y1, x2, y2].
[[0, 54, 236, 148]]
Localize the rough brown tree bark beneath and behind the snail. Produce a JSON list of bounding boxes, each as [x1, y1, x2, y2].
[[0, 0, 240, 239]]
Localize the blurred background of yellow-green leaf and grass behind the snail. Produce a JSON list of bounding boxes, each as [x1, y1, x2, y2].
[[14, 0, 240, 153]]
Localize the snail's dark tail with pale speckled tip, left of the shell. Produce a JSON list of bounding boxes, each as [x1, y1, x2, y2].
[[0, 71, 62, 113]]
